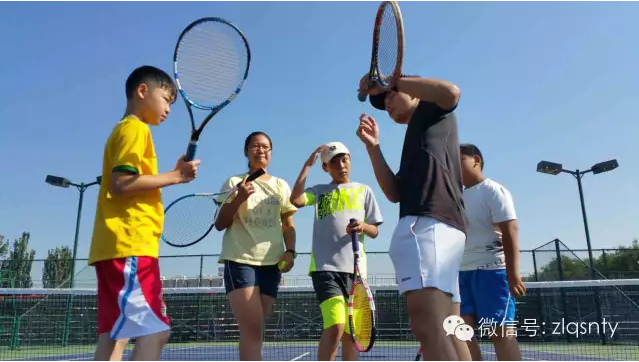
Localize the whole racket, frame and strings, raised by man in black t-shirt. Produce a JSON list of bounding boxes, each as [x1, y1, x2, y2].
[[357, 1, 404, 102]]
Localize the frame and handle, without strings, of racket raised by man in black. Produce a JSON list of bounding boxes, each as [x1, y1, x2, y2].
[[357, 1, 404, 102]]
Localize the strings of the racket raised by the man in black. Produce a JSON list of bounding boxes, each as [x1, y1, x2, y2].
[[377, 5, 398, 79]]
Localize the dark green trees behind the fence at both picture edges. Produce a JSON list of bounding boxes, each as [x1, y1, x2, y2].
[[0, 232, 639, 288]]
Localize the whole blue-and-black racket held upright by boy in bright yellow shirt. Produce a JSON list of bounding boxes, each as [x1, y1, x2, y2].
[[173, 18, 251, 161]]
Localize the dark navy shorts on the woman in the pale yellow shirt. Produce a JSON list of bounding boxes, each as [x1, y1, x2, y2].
[[224, 260, 282, 298]]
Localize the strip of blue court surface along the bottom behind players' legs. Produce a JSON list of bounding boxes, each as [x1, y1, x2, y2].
[[3, 343, 639, 361]]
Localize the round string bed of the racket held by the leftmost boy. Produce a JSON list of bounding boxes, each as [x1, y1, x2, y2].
[[176, 21, 249, 107]]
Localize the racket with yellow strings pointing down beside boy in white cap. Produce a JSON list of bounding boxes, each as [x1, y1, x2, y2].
[[348, 219, 377, 352]]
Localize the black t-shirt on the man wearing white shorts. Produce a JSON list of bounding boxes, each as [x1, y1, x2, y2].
[[396, 101, 467, 233]]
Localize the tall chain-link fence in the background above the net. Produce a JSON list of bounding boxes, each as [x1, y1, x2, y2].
[[0, 239, 639, 288]]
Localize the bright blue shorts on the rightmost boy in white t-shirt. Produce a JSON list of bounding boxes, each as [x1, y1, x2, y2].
[[459, 269, 515, 326]]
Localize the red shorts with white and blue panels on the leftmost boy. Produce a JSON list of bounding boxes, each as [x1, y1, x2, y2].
[[95, 256, 170, 340]]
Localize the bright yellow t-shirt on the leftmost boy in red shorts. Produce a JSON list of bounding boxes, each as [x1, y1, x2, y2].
[[89, 116, 164, 264]]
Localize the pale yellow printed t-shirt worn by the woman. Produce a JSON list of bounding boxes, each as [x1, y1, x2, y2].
[[219, 174, 297, 265]]
